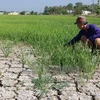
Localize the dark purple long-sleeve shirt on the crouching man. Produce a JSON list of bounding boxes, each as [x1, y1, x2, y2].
[[68, 24, 100, 45]]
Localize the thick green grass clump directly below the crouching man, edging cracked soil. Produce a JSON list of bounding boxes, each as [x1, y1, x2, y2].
[[51, 43, 100, 77]]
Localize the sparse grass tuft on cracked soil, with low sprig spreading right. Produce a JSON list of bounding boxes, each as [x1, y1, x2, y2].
[[27, 51, 68, 98]]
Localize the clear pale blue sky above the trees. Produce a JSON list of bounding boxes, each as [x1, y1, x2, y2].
[[0, 0, 98, 12]]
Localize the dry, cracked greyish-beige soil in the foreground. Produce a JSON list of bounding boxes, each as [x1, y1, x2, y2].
[[0, 44, 100, 100]]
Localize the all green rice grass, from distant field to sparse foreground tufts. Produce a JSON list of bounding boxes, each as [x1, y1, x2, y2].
[[0, 15, 100, 98]]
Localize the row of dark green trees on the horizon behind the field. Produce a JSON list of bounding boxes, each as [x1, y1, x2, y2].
[[43, 2, 100, 15]]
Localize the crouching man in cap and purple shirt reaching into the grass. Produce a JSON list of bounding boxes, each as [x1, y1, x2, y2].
[[64, 16, 100, 50]]
